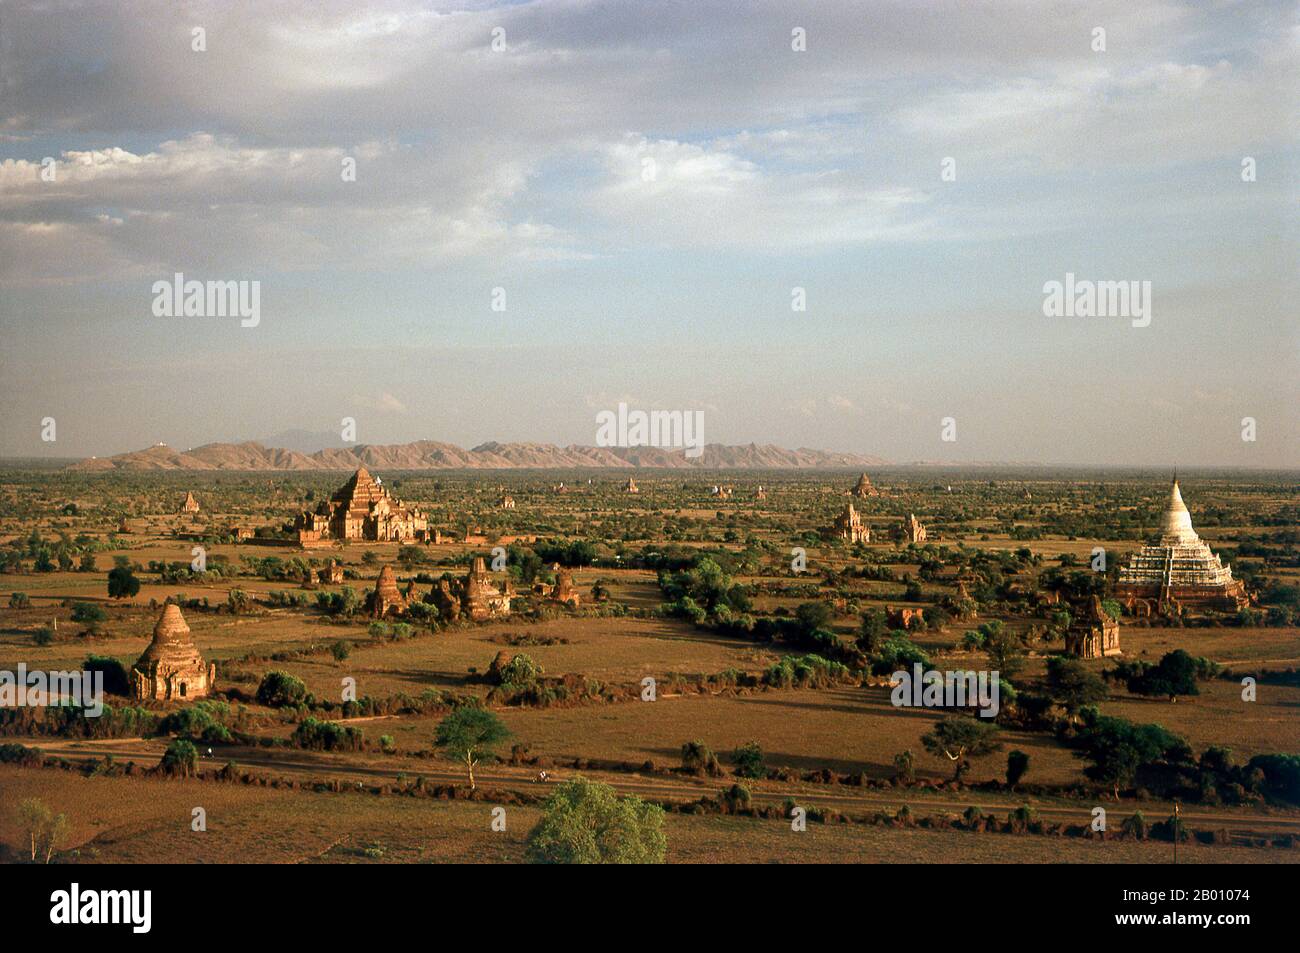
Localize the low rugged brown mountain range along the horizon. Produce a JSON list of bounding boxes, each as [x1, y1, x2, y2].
[[69, 441, 885, 472]]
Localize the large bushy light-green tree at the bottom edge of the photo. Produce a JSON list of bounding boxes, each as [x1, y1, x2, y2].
[[525, 777, 668, 863]]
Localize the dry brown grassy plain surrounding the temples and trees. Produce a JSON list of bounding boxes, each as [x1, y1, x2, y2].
[[0, 471, 1300, 863]]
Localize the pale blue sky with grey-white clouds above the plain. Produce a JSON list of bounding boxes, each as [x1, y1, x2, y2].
[[0, 0, 1300, 468]]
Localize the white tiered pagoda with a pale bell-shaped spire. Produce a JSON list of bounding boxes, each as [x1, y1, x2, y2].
[[1115, 477, 1247, 611]]
